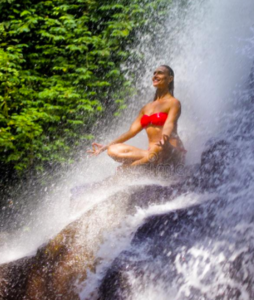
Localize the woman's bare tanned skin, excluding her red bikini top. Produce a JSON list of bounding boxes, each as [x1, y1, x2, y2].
[[87, 66, 185, 167]]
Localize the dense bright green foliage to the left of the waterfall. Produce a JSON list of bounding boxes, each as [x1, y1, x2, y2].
[[0, 0, 170, 176]]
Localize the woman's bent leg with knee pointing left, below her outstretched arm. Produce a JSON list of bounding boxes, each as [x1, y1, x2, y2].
[[108, 144, 148, 165]]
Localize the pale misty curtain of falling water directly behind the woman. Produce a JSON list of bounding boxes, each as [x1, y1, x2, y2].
[[135, 0, 254, 163]]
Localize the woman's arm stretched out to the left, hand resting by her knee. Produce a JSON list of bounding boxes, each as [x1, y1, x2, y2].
[[87, 107, 144, 155]]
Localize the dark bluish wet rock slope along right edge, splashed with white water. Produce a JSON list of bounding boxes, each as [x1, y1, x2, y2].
[[97, 69, 254, 300]]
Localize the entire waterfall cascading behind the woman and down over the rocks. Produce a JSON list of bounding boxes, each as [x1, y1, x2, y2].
[[0, 0, 254, 300]]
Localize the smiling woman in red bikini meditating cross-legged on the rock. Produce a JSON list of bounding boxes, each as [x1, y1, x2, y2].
[[87, 65, 186, 167]]
